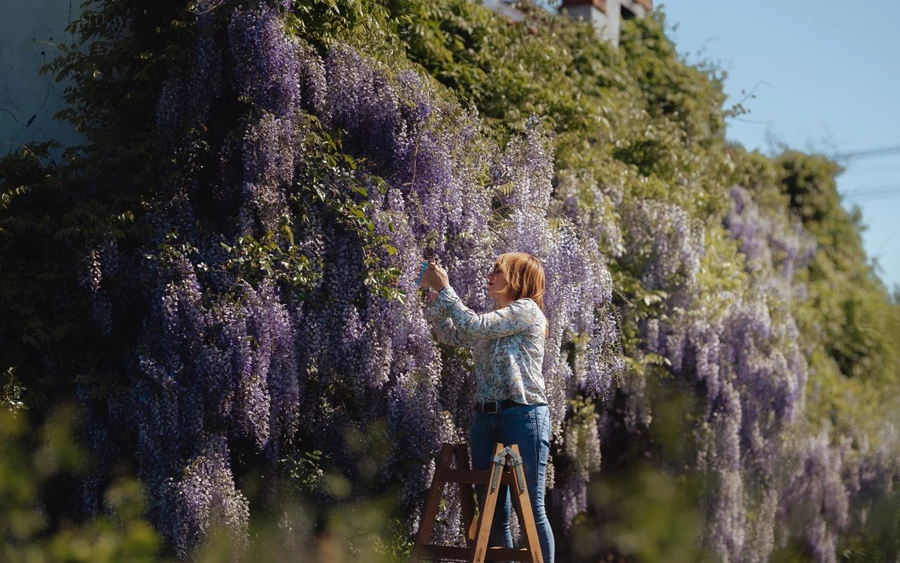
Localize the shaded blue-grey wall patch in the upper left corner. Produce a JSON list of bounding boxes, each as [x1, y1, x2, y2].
[[0, 0, 83, 156]]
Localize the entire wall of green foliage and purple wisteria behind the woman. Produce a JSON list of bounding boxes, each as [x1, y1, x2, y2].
[[0, 0, 900, 561]]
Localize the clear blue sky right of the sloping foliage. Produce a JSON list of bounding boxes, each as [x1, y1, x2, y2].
[[657, 0, 900, 296]]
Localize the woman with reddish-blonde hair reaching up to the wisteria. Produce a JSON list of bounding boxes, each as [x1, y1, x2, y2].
[[421, 252, 554, 563]]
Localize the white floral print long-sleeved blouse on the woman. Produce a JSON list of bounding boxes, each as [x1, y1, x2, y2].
[[425, 287, 547, 405]]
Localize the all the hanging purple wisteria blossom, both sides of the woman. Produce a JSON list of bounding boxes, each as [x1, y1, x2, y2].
[[63, 0, 900, 561]]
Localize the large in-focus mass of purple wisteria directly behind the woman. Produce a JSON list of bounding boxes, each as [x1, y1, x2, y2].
[[84, 2, 620, 558]]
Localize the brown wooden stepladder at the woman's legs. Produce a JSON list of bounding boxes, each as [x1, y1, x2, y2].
[[412, 443, 544, 563]]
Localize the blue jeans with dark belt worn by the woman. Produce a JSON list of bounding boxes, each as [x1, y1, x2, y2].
[[469, 405, 554, 563]]
